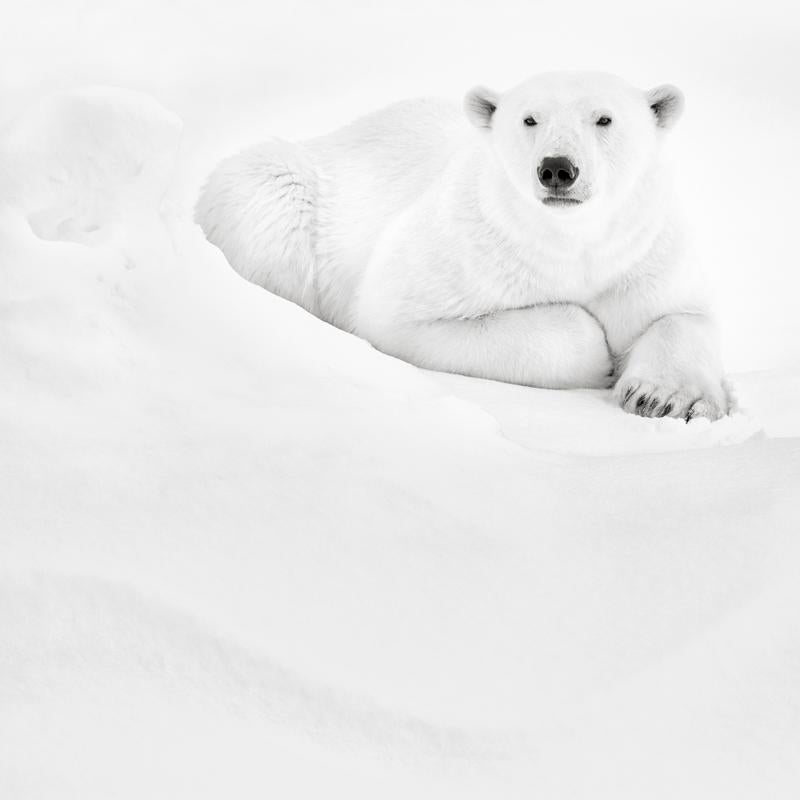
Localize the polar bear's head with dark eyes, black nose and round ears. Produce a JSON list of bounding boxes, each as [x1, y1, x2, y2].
[[464, 72, 684, 215]]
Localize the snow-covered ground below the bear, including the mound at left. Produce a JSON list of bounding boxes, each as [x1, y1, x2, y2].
[[0, 11, 800, 800]]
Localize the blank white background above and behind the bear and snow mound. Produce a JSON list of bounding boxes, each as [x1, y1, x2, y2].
[[0, 0, 800, 372]]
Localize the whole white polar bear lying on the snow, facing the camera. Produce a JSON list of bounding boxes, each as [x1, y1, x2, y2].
[[196, 72, 728, 420]]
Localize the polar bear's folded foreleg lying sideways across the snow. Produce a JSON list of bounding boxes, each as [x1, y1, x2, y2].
[[364, 303, 613, 389]]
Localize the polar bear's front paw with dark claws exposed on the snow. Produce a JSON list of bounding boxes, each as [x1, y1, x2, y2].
[[614, 373, 729, 422]]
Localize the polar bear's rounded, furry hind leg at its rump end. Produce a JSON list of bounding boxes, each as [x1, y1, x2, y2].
[[195, 140, 317, 312]]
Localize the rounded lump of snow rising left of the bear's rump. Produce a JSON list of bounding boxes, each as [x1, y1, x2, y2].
[[0, 88, 181, 242]]
